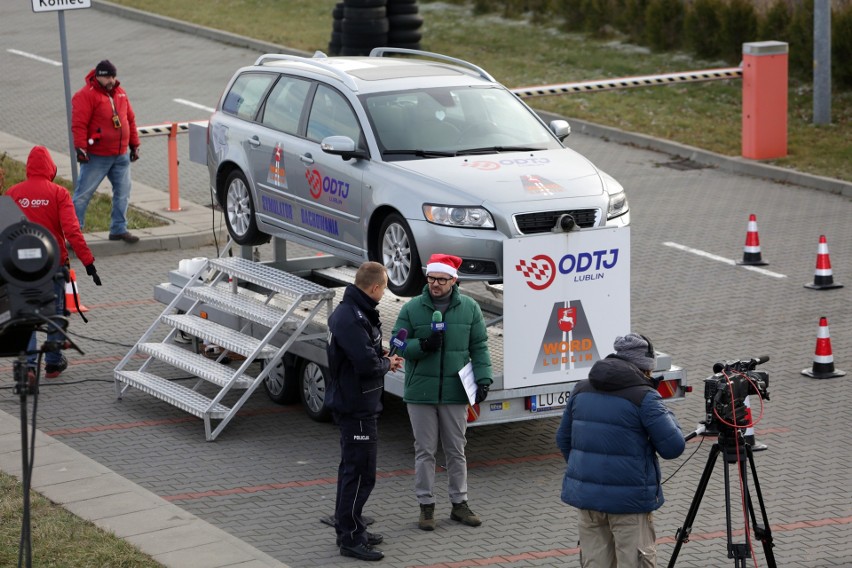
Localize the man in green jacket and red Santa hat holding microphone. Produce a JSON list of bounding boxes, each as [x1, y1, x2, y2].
[[393, 254, 492, 531]]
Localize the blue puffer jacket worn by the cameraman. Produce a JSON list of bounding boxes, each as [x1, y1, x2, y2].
[[556, 355, 686, 514]]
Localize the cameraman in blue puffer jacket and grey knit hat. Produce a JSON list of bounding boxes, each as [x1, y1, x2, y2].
[[556, 333, 686, 568]]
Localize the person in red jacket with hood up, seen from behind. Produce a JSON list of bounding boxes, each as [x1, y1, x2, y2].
[[6, 146, 101, 379]]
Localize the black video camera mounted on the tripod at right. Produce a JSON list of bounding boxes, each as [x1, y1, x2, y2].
[[703, 355, 769, 438]]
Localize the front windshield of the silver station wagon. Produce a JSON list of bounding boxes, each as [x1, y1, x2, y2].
[[363, 87, 561, 161]]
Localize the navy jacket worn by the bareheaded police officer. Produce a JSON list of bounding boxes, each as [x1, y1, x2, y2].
[[326, 284, 390, 418]]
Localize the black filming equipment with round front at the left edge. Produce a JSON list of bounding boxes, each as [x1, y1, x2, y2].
[[0, 196, 68, 357]]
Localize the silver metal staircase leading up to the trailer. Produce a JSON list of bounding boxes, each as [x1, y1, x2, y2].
[[114, 257, 334, 441]]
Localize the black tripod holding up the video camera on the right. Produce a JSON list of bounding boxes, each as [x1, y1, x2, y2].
[[669, 426, 776, 568]]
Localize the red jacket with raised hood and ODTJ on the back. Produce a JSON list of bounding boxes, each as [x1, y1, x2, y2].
[[6, 146, 95, 266]]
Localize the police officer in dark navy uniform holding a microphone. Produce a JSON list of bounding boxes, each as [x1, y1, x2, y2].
[[326, 262, 403, 561]]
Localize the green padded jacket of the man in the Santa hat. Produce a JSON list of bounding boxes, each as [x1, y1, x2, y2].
[[393, 286, 492, 404]]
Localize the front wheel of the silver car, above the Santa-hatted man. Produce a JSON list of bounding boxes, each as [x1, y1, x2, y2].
[[376, 213, 426, 296]]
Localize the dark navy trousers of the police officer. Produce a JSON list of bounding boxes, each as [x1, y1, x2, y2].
[[334, 415, 379, 546]]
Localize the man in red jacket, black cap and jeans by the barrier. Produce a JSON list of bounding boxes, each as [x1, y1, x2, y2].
[[71, 59, 139, 244]]
